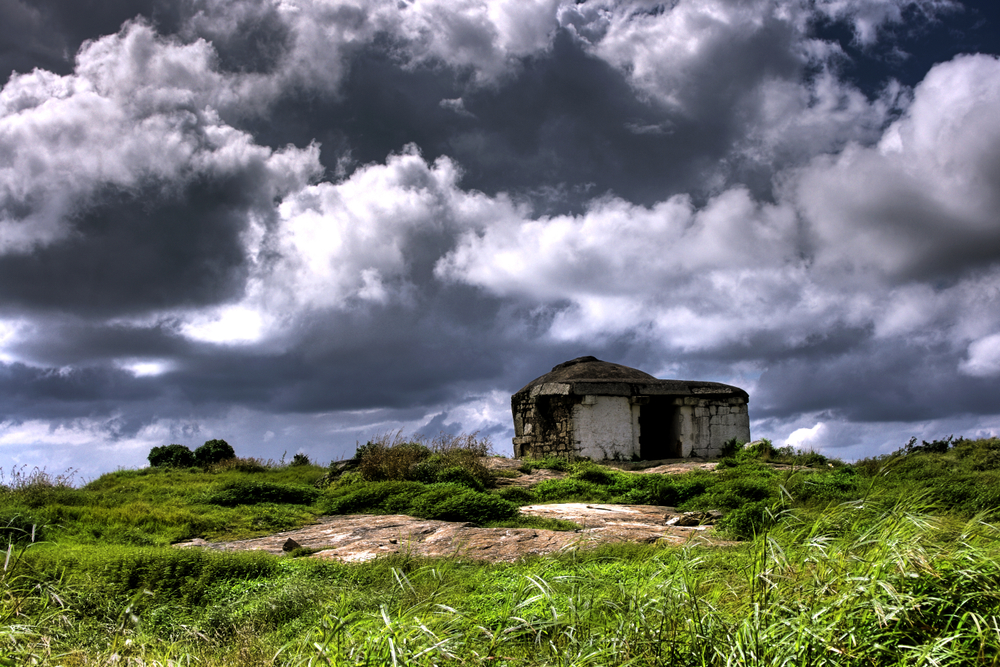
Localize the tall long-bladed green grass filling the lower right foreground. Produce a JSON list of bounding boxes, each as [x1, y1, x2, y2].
[[286, 504, 1000, 666]]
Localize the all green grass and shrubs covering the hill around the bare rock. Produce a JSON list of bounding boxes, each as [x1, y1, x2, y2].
[[0, 435, 1000, 666]]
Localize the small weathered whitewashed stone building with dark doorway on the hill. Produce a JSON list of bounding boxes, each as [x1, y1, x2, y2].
[[510, 357, 750, 460]]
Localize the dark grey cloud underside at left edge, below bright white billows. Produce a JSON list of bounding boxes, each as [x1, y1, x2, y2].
[[0, 177, 259, 316]]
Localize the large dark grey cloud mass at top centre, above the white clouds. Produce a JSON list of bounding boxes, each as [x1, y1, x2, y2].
[[241, 31, 729, 212]]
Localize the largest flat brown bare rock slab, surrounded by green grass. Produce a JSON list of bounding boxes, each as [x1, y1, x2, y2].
[[174, 503, 724, 562]]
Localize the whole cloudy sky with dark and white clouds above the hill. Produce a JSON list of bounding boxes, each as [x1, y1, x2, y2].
[[0, 0, 1000, 479]]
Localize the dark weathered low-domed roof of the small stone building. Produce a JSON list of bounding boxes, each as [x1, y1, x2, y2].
[[514, 356, 747, 398]]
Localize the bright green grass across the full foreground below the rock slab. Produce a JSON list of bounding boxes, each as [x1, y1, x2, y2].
[[0, 500, 1000, 667]]
